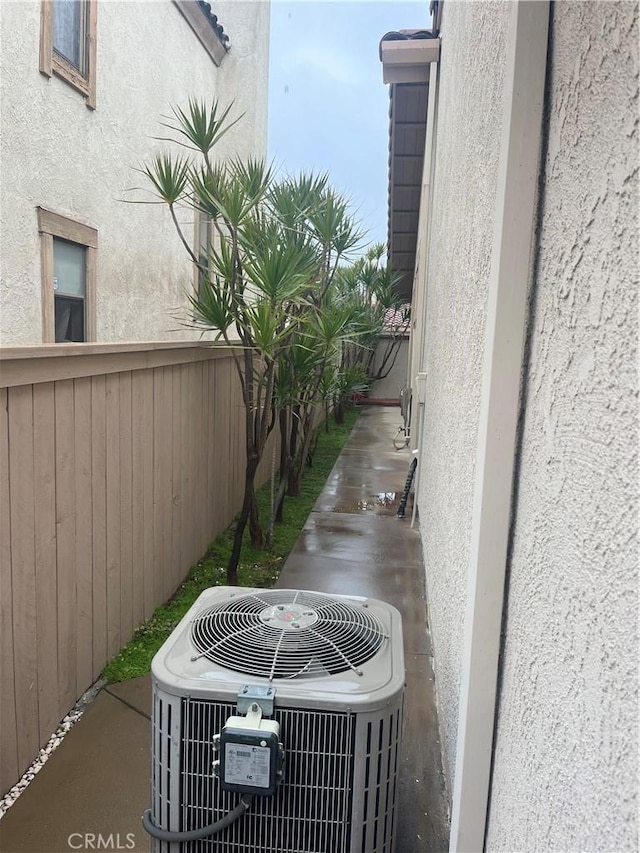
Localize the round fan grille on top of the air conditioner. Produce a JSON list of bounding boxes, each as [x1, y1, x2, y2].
[[191, 589, 387, 679]]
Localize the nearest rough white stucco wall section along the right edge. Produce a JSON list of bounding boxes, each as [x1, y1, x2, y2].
[[487, 3, 638, 851]]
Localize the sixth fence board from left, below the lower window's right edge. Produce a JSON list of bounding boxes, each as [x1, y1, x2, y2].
[[91, 376, 107, 679]]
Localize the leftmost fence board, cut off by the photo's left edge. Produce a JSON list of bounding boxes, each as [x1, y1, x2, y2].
[[0, 388, 22, 791]]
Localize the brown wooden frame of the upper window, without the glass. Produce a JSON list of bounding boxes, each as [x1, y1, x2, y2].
[[40, 0, 98, 110]]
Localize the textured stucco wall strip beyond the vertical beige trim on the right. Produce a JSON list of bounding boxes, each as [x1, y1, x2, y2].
[[414, 3, 508, 789]]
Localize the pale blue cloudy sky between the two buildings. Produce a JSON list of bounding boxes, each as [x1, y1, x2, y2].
[[268, 0, 431, 250]]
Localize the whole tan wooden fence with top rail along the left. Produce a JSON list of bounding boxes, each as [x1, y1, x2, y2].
[[0, 343, 270, 792]]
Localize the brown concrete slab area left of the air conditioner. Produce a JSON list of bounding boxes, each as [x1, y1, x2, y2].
[[0, 676, 151, 853]]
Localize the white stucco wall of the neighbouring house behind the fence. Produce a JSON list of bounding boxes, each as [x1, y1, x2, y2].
[[0, 0, 269, 345]]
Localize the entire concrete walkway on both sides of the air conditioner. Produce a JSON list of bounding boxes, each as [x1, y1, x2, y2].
[[0, 407, 448, 853]]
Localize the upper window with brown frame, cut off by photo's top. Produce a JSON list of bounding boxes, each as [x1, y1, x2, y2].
[[40, 0, 97, 109]]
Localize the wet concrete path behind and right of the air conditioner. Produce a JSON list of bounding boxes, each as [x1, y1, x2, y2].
[[277, 408, 448, 853]]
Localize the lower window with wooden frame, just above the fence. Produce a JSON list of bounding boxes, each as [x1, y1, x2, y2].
[[38, 207, 98, 343]]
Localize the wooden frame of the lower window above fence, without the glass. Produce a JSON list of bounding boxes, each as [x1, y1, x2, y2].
[[37, 207, 98, 344]]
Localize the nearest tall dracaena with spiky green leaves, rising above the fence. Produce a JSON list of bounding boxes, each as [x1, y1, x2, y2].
[[142, 100, 370, 584]]
